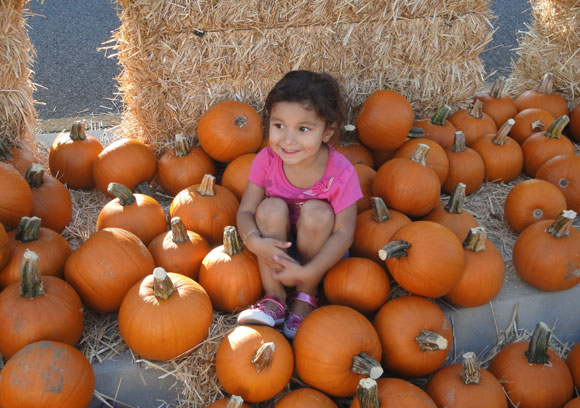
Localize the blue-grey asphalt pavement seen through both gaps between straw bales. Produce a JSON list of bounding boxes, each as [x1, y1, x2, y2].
[[28, 0, 530, 120]]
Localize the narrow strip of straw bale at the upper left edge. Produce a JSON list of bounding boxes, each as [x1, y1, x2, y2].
[[0, 0, 36, 150]]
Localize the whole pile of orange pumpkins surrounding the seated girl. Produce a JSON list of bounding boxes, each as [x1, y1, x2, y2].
[[0, 74, 580, 408]]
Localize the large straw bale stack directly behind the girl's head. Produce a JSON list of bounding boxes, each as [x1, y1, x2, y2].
[[111, 0, 493, 153]]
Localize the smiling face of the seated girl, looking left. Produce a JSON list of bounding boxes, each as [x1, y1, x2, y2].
[[269, 102, 335, 166]]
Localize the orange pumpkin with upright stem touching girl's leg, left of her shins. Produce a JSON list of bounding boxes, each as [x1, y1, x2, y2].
[[199, 225, 264, 312]]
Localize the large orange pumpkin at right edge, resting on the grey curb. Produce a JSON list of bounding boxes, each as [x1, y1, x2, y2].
[[512, 210, 580, 290]]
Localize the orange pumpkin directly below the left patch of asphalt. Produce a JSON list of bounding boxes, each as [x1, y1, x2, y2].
[[48, 121, 103, 189]]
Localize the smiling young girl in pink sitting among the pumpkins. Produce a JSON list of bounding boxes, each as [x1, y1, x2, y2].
[[237, 71, 362, 338]]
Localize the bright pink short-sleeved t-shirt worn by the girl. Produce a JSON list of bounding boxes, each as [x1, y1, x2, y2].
[[249, 146, 363, 225]]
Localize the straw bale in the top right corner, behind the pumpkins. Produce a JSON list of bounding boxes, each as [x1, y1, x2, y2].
[[508, 0, 580, 108]]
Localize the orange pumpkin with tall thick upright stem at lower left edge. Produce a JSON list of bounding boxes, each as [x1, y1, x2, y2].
[[0, 250, 84, 358]]
